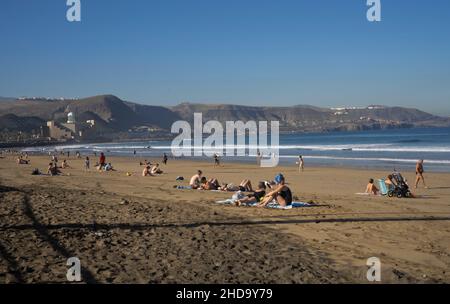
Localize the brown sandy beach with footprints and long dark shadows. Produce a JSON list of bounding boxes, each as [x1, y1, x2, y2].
[[0, 155, 450, 283]]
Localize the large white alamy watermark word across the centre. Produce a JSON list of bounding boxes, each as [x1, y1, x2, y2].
[[171, 113, 280, 167]]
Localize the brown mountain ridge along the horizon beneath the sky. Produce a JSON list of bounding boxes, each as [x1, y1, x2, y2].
[[0, 95, 450, 132]]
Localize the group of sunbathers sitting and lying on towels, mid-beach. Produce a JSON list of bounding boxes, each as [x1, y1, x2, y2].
[[189, 170, 293, 207]]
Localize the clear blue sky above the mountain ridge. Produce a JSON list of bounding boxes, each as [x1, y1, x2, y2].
[[0, 0, 450, 115]]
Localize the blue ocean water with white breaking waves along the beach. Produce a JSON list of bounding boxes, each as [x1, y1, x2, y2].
[[22, 128, 450, 172]]
